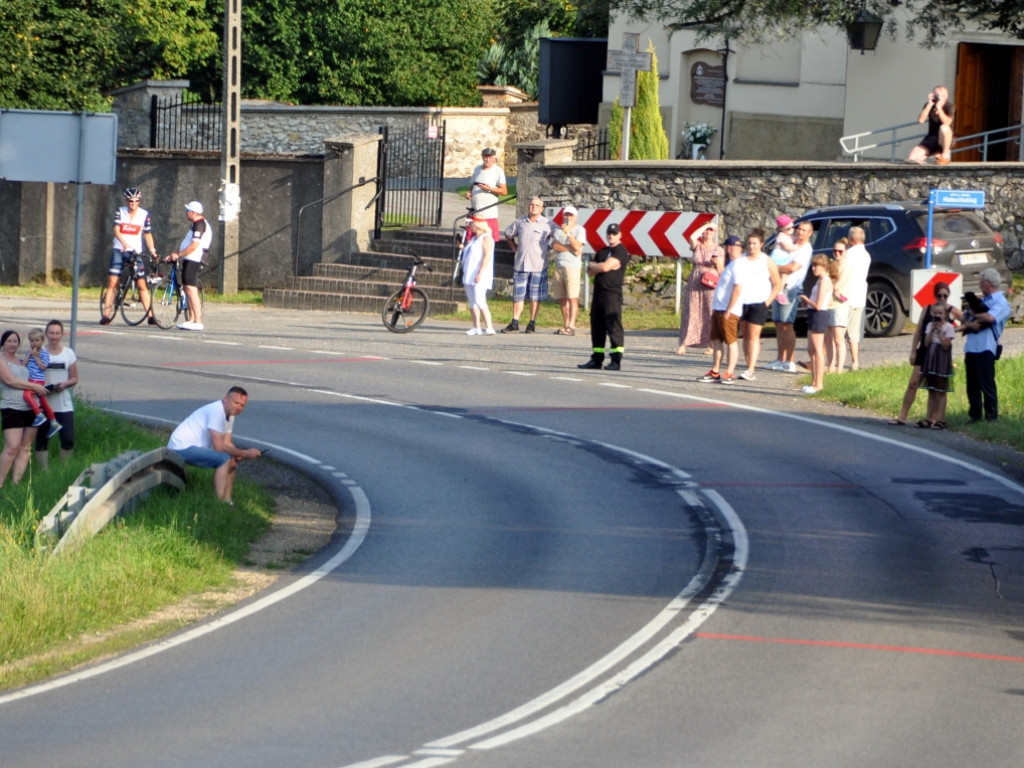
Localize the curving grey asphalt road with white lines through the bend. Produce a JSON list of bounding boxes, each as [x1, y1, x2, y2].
[[0, 300, 1024, 768]]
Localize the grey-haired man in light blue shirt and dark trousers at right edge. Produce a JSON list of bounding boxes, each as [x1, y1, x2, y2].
[[964, 267, 1010, 424]]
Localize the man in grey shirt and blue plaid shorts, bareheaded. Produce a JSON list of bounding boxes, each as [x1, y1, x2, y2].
[[502, 198, 551, 334]]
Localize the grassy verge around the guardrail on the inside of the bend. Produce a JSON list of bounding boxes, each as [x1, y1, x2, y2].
[[0, 401, 273, 689]]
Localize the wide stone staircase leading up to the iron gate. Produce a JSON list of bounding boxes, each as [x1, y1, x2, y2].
[[263, 229, 514, 315]]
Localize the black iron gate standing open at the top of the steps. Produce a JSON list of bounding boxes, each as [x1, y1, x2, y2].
[[374, 121, 445, 238]]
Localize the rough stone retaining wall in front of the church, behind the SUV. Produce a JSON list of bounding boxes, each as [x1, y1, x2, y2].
[[519, 151, 1024, 268]]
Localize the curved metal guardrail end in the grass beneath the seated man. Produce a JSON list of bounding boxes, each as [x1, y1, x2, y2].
[[36, 446, 185, 554]]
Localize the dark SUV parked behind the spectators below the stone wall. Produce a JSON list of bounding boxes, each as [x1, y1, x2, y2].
[[765, 201, 1012, 336]]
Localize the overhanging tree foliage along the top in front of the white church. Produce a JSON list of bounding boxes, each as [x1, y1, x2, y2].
[[610, 0, 1024, 46]]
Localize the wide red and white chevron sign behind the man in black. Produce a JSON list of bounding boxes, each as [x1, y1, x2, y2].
[[547, 208, 718, 259]]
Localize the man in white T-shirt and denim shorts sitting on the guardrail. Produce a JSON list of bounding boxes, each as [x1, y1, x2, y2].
[[167, 387, 262, 504]]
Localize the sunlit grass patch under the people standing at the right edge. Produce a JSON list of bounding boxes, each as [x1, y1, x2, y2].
[[816, 355, 1024, 452]]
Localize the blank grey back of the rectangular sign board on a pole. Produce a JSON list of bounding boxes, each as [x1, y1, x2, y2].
[[0, 110, 118, 184]]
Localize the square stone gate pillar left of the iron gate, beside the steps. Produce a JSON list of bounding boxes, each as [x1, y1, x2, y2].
[[321, 133, 381, 262]]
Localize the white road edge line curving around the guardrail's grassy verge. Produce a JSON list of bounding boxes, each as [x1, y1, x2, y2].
[[0, 442, 371, 706]]
